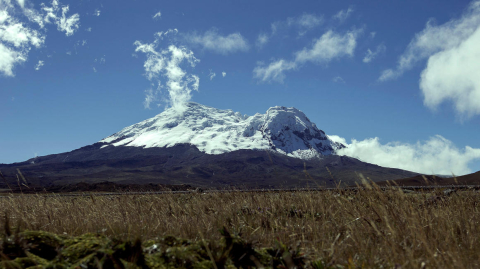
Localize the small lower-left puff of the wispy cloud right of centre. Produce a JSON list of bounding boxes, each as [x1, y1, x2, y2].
[[253, 59, 297, 83]]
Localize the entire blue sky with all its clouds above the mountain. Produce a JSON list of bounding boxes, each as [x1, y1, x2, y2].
[[0, 0, 480, 174]]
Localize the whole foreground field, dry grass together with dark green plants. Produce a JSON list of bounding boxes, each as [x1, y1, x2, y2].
[[0, 185, 480, 268]]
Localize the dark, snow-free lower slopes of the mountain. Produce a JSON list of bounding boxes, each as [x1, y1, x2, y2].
[[0, 143, 417, 188]]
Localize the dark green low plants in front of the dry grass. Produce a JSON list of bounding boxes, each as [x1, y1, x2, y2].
[[0, 228, 318, 269]]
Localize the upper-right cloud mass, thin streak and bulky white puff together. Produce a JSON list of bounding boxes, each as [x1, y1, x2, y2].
[[379, 0, 480, 120]]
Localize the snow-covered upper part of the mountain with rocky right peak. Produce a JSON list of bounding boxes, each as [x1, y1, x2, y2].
[[100, 103, 343, 159]]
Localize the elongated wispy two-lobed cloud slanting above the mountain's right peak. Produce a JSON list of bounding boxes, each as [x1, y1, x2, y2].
[[253, 30, 362, 83]]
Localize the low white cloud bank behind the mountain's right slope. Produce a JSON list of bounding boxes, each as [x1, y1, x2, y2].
[[328, 135, 480, 175]]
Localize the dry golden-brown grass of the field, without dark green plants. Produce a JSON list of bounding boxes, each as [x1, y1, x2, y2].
[[0, 186, 480, 268]]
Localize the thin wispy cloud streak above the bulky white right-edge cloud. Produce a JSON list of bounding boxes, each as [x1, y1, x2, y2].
[[379, 0, 480, 81]]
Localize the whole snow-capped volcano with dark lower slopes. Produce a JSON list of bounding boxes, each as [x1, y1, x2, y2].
[[0, 103, 417, 188]]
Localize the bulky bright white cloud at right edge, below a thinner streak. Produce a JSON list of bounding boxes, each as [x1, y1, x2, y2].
[[420, 27, 480, 118]]
